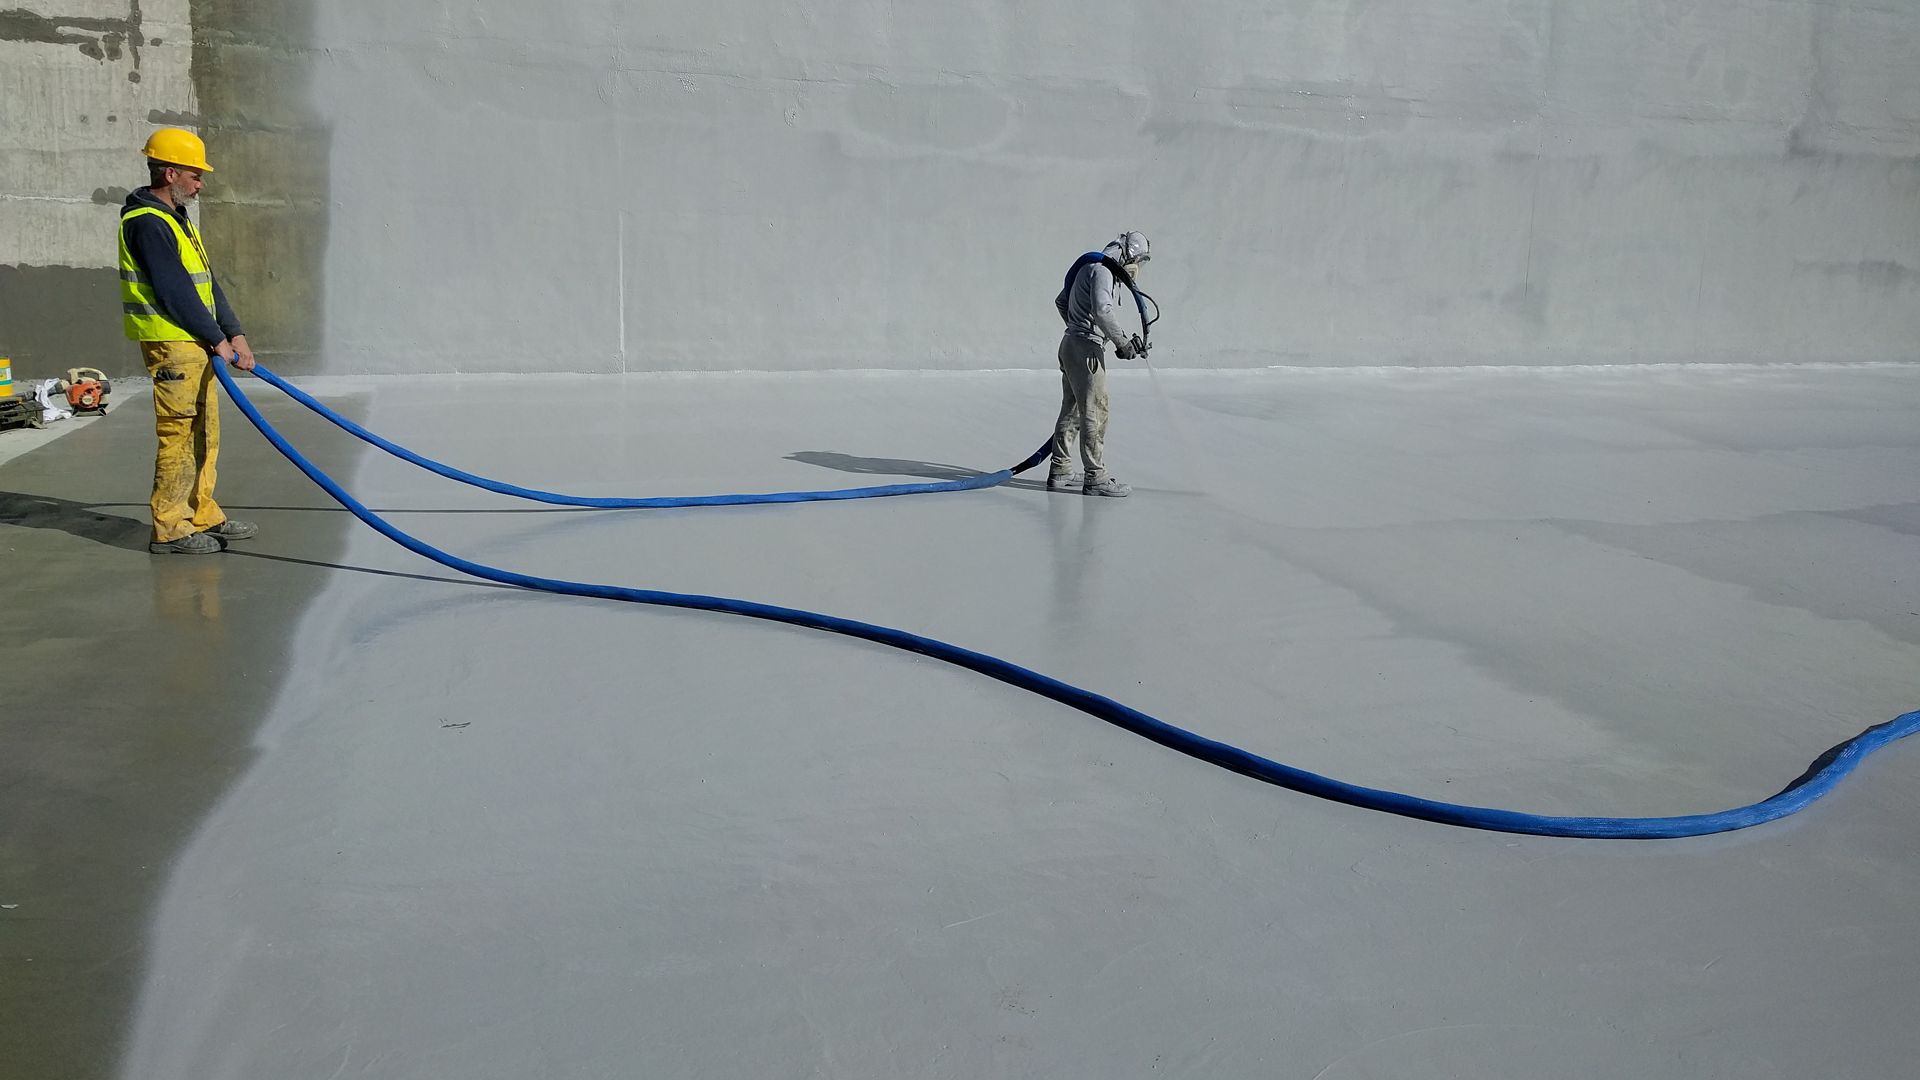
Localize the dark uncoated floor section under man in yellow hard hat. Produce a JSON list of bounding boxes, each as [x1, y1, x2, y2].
[[0, 394, 361, 1080]]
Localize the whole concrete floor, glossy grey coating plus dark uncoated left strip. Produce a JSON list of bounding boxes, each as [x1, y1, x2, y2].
[[0, 365, 1920, 1080]]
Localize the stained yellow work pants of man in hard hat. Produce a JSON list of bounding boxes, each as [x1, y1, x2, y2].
[[140, 342, 227, 544]]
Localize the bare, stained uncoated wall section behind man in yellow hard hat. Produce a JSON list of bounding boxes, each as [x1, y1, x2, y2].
[[0, 0, 326, 377]]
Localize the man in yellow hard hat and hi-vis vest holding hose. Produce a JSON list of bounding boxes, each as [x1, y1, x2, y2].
[[119, 127, 259, 555]]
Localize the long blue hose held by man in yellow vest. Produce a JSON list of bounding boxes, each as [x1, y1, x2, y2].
[[213, 363, 1920, 840]]
